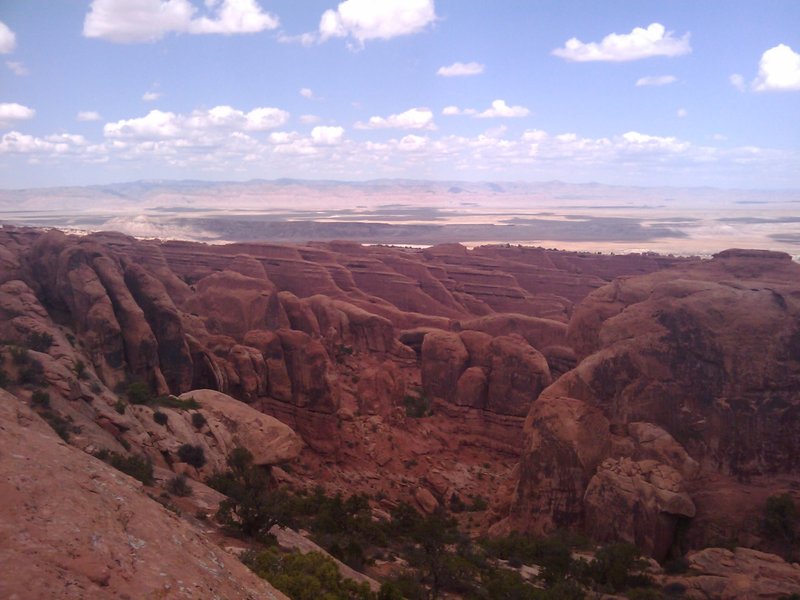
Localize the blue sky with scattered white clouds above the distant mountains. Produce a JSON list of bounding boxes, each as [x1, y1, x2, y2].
[[0, 0, 800, 189]]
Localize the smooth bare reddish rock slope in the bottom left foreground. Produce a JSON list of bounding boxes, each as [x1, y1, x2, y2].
[[0, 390, 285, 600]]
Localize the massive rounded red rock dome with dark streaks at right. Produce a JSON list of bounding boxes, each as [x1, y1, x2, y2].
[[511, 250, 800, 558]]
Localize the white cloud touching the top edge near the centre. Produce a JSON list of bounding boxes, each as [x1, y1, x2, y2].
[[319, 0, 436, 44]]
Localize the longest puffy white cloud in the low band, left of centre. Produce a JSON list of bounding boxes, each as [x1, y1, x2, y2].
[[103, 106, 289, 139]]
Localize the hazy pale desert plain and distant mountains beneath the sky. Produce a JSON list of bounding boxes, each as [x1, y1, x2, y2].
[[0, 180, 800, 256]]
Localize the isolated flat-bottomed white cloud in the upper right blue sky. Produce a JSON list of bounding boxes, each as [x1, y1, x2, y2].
[[553, 23, 692, 62]]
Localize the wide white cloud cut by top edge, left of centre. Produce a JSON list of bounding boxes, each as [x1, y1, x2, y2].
[[83, 0, 279, 43]]
